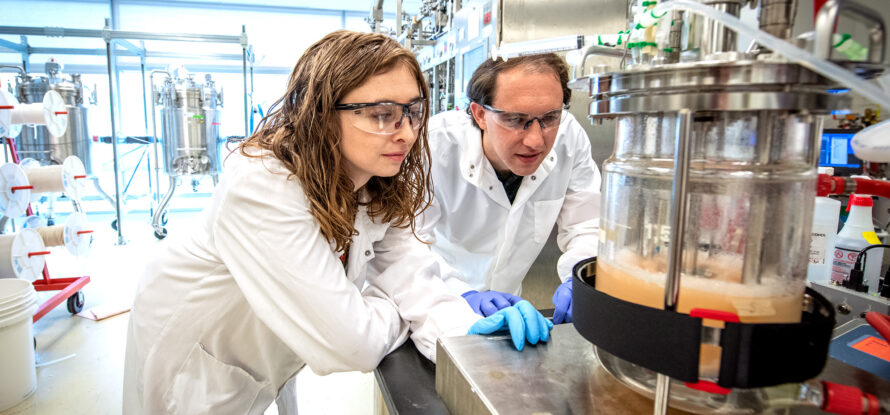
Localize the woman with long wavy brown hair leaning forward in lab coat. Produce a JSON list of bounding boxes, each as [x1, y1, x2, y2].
[[124, 31, 552, 414]]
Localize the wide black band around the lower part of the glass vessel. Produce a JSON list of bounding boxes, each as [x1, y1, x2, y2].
[[572, 257, 835, 388]]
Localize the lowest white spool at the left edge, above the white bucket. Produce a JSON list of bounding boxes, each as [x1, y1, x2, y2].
[[0, 228, 49, 281]]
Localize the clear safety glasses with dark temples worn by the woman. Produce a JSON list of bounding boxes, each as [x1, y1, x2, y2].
[[334, 99, 425, 134]]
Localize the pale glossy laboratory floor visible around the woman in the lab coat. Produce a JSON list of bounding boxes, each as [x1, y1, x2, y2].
[[0, 210, 375, 415]]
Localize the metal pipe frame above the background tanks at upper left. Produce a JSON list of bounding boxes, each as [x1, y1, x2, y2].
[[0, 19, 253, 245]]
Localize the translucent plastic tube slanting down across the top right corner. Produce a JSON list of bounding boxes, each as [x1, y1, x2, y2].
[[652, 0, 890, 108]]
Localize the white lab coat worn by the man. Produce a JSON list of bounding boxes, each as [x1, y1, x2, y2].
[[423, 111, 602, 295]]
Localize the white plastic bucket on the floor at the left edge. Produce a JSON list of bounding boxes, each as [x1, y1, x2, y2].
[[0, 279, 37, 411]]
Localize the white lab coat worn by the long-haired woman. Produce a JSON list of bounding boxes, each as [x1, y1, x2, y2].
[[123, 152, 479, 414]]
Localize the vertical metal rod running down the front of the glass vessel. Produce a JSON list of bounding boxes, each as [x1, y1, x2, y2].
[[654, 109, 692, 414]]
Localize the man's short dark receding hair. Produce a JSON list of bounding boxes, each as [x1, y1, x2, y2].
[[467, 53, 572, 128]]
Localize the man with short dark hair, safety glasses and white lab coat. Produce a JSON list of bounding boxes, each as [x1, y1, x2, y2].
[[423, 54, 601, 323]]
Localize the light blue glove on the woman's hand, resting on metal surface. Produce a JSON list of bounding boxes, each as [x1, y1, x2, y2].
[[467, 300, 553, 350]]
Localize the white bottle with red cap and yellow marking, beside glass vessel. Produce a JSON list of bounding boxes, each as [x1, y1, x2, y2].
[[831, 194, 883, 292]]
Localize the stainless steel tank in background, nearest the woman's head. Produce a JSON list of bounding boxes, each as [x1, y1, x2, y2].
[[151, 71, 223, 239]]
